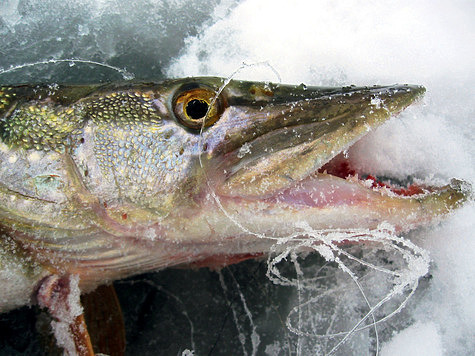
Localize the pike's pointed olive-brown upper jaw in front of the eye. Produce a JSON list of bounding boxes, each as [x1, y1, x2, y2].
[[203, 82, 425, 198]]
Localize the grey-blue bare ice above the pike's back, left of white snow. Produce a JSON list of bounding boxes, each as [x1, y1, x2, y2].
[[0, 0, 238, 83]]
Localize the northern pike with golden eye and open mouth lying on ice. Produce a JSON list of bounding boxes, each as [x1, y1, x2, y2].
[[0, 77, 471, 354]]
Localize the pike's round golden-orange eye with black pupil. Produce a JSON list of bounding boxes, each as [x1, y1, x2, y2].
[[173, 87, 224, 130]]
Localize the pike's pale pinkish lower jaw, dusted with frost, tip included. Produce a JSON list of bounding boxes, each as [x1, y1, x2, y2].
[[215, 160, 466, 237]]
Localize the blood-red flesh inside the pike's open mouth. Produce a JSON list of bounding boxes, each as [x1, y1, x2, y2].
[[318, 153, 431, 196]]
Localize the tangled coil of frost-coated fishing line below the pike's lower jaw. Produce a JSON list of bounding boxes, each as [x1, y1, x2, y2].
[[267, 225, 430, 355]]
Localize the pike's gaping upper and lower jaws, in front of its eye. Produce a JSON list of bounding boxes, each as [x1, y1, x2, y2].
[[196, 84, 471, 235]]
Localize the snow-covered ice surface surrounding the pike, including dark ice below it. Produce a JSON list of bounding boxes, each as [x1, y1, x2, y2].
[[0, 0, 475, 356]]
